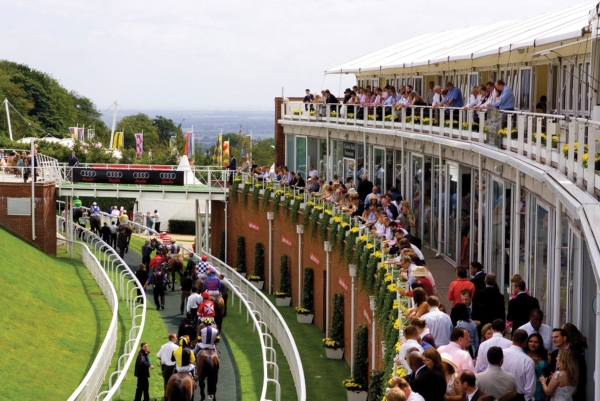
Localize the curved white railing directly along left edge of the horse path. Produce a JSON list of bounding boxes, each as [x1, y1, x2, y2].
[[57, 216, 146, 400]]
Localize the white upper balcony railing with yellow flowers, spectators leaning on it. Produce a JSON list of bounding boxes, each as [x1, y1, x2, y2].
[[281, 102, 600, 195]]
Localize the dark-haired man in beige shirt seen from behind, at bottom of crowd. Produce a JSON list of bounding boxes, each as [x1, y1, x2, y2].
[[475, 347, 517, 399]]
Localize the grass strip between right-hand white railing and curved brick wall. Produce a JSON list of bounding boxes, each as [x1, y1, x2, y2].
[[269, 296, 350, 401]]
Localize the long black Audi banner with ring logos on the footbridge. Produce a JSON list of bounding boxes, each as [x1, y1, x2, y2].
[[72, 167, 185, 185]]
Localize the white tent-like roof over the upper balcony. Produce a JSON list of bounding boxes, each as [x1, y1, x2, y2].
[[326, 2, 599, 74]]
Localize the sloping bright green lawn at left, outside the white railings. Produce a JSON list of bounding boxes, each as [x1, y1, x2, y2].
[[0, 229, 111, 400]]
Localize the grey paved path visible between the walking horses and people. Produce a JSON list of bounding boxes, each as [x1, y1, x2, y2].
[[124, 249, 241, 401]]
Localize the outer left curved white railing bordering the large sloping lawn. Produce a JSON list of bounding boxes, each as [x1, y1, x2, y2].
[[61, 240, 119, 400]]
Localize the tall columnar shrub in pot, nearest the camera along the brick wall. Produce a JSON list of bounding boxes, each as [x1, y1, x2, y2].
[[343, 324, 369, 401]]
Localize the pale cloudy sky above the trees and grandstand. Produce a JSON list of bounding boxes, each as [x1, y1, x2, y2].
[[0, 0, 582, 111]]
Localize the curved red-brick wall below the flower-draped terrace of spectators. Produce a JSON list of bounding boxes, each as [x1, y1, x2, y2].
[[212, 190, 382, 369]]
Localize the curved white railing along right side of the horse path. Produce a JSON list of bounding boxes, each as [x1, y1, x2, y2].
[[89, 212, 306, 401]]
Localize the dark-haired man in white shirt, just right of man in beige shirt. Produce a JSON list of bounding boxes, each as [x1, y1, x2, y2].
[[502, 330, 536, 400]]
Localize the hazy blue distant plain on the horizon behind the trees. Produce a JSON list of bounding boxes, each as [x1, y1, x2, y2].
[[101, 109, 275, 148]]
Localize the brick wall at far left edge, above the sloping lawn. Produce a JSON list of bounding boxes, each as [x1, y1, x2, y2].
[[0, 183, 56, 256]]
